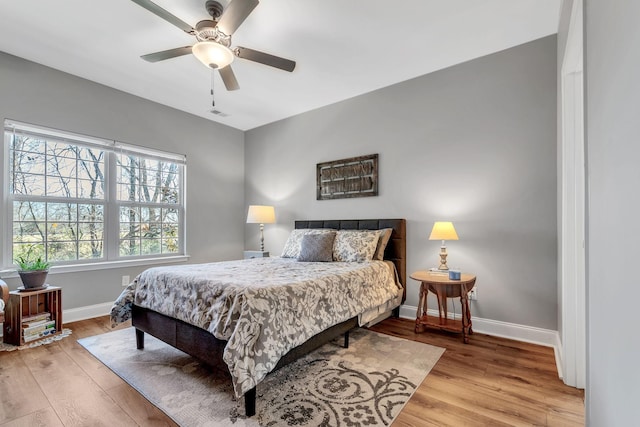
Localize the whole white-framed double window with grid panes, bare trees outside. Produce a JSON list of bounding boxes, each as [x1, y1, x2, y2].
[[4, 121, 185, 265]]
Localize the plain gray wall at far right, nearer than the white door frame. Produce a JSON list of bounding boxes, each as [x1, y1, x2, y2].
[[585, 0, 640, 426]]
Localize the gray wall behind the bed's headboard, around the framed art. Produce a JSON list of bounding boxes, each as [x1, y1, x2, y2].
[[245, 36, 557, 330]]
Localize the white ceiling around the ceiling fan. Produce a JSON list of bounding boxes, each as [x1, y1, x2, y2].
[[0, 0, 562, 130]]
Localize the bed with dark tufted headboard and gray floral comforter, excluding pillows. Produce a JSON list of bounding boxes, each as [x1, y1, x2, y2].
[[112, 219, 406, 416]]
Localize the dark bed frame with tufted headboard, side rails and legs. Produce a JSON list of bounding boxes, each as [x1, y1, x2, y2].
[[132, 219, 407, 417]]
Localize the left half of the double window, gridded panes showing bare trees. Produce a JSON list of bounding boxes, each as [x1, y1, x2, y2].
[[9, 134, 105, 262]]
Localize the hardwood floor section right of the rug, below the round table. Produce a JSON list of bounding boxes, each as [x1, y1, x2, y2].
[[372, 319, 584, 426]]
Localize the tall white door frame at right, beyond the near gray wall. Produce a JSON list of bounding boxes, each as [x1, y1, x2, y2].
[[560, 0, 586, 388]]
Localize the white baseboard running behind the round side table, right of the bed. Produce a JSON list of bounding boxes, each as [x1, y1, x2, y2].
[[400, 305, 562, 378]]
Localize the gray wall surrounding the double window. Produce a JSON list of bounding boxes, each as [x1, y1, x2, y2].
[[0, 52, 246, 309]]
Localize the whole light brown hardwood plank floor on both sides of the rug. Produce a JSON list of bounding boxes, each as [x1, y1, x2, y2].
[[0, 316, 584, 427]]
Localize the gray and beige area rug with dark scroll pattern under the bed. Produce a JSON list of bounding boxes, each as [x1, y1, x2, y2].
[[78, 328, 444, 427]]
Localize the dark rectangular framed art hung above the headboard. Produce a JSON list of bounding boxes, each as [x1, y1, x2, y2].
[[316, 154, 378, 200]]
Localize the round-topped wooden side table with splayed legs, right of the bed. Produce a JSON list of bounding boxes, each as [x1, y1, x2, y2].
[[411, 271, 476, 344]]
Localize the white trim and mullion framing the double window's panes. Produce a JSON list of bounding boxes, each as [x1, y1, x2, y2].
[[0, 119, 189, 272]]
